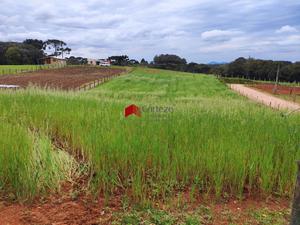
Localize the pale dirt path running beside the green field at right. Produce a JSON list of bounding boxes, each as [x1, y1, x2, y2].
[[230, 84, 300, 111]]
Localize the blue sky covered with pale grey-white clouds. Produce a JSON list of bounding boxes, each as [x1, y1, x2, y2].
[[0, 0, 300, 63]]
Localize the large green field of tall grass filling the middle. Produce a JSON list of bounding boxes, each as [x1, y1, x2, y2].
[[0, 68, 300, 203]]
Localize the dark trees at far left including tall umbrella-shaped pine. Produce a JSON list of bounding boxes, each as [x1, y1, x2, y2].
[[0, 39, 71, 65]]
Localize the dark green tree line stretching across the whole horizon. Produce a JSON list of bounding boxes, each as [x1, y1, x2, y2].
[[0, 39, 300, 82]]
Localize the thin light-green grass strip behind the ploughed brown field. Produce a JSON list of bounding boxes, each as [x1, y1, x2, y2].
[[0, 65, 65, 75]]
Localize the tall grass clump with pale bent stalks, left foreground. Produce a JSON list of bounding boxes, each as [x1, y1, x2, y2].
[[0, 121, 76, 199]]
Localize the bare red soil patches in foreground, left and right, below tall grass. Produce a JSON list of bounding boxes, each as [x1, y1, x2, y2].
[[0, 189, 290, 225]]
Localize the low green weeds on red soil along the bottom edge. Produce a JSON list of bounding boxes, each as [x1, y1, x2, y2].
[[111, 205, 290, 225]]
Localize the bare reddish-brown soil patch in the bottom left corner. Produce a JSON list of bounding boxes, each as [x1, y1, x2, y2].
[[0, 184, 121, 225]]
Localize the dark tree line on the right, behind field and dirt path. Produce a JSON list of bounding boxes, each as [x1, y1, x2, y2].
[[149, 54, 300, 82]]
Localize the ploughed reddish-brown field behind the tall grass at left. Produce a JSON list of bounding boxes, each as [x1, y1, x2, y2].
[[0, 67, 125, 90]]
